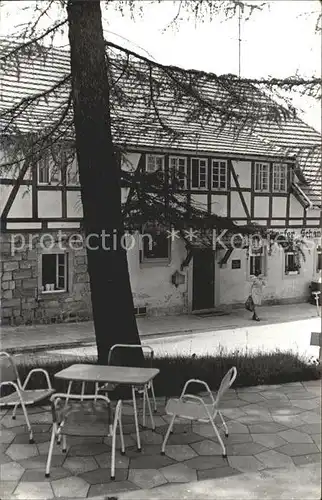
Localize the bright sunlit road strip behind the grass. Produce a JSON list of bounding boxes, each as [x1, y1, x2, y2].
[[19, 317, 321, 359]]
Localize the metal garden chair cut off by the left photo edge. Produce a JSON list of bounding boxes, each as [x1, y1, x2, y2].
[[0, 351, 55, 443]]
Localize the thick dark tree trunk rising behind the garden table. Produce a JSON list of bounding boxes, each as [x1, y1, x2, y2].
[[67, 0, 142, 365]]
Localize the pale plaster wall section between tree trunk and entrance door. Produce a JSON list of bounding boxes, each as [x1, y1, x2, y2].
[[127, 237, 187, 314]]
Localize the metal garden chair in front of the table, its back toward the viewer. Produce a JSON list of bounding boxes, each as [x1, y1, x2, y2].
[[45, 393, 125, 479]]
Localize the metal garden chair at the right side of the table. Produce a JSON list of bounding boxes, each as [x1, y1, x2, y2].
[[161, 366, 237, 457]]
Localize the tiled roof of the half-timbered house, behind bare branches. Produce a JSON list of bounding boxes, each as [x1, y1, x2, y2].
[[0, 42, 321, 204]]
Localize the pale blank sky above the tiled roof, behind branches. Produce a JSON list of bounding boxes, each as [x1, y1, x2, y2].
[[0, 0, 321, 130]]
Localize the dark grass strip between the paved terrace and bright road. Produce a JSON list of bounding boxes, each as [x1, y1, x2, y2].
[[8, 350, 321, 399]]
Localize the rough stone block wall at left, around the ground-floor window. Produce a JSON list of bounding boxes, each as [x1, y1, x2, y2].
[[0, 231, 91, 325]]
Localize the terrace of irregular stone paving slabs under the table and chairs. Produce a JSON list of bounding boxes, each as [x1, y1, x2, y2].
[[0, 381, 321, 500]]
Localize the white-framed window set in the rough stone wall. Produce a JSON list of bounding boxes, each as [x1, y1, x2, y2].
[[41, 253, 68, 292]]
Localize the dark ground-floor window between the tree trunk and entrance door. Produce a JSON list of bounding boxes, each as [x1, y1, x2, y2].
[[141, 224, 171, 262]]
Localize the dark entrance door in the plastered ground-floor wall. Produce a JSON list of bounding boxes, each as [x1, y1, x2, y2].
[[192, 249, 215, 311]]
